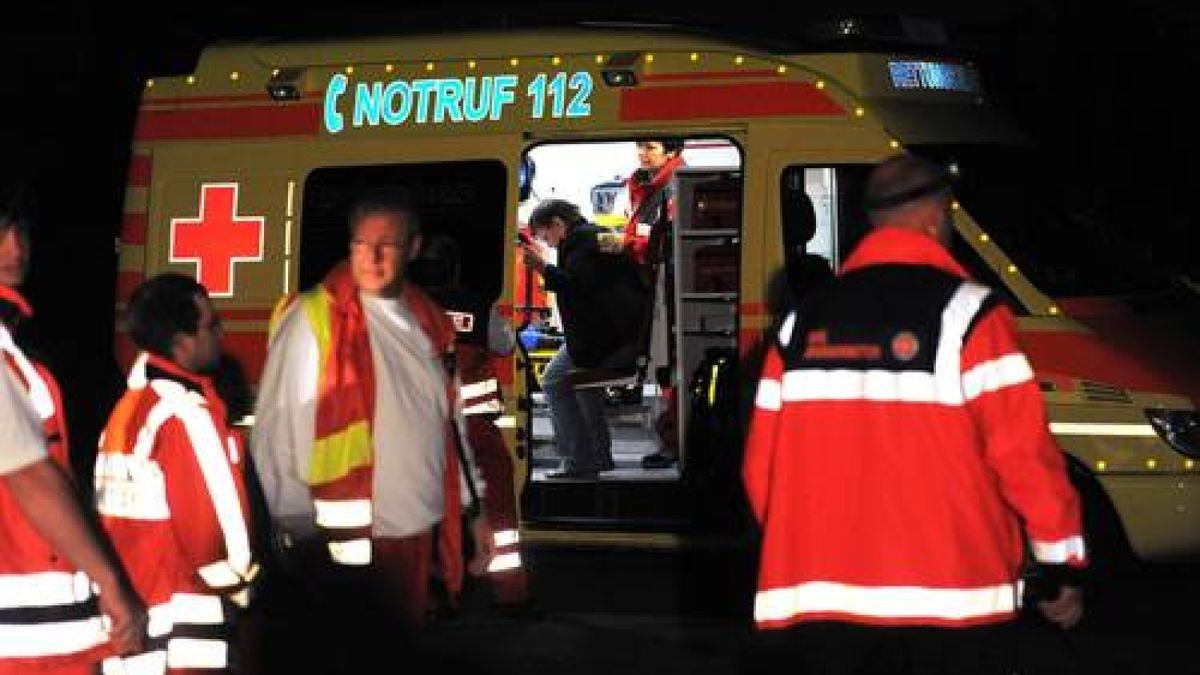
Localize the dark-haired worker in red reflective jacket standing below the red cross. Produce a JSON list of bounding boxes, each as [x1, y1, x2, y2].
[[96, 274, 258, 675]]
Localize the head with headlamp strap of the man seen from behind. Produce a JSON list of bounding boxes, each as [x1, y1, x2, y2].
[[865, 153, 953, 244]]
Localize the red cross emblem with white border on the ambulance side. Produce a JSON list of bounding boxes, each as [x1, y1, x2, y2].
[[169, 183, 266, 298]]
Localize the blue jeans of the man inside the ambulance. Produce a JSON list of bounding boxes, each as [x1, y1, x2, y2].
[[541, 345, 612, 473]]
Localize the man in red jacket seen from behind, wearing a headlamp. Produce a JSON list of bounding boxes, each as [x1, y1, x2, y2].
[[743, 154, 1086, 675]]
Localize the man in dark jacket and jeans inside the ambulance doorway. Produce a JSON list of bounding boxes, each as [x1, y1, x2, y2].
[[522, 199, 648, 479]]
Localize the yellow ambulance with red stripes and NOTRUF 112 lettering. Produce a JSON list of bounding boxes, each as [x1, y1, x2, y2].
[[116, 28, 1200, 558]]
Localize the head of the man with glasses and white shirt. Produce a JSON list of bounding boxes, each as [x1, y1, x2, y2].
[[349, 193, 421, 298]]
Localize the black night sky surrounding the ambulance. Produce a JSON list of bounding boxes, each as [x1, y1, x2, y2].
[[0, 0, 1200, 446]]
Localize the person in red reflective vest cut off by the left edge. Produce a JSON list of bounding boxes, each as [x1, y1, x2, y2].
[[0, 211, 145, 675]]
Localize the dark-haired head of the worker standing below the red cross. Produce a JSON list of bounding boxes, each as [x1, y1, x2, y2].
[[128, 273, 221, 372]]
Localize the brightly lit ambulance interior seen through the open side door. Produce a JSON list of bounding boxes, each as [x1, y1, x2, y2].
[[516, 139, 742, 483]]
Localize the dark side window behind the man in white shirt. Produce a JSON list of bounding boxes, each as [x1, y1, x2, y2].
[[298, 160, 508, 299]]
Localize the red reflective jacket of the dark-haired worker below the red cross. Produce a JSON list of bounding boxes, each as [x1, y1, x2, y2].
[[96, 354, 257, 671]]
